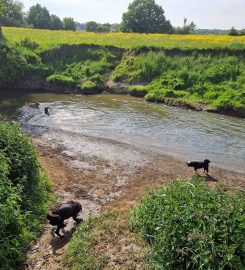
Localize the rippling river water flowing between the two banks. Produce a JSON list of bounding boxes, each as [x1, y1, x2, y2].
[[0, 91, 245, 172]]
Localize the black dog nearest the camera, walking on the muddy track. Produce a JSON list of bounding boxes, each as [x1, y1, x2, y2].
[[47, 201, 82, 238]]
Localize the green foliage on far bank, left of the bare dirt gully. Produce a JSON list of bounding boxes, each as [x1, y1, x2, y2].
[[45, 47, 118, 89]]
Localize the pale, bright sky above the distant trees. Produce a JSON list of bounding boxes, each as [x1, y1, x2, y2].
[[21, 0, 245, 29]]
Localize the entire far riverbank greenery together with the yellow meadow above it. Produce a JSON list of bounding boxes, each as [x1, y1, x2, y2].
[[0, 28, 245, 117]]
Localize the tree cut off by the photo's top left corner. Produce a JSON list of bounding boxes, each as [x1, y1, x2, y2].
[[0, 0, 24, 26]]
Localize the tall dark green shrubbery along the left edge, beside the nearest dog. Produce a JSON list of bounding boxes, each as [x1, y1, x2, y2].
[[0, 123, 50, 269]]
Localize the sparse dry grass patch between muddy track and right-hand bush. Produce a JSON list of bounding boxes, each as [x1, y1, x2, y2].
[[64, 212, 151, 270]]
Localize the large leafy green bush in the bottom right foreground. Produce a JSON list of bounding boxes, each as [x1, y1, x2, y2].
[[132, 178, 245, 270]]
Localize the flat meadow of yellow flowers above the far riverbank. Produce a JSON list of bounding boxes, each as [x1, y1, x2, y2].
[[3, 27, 245, 50]]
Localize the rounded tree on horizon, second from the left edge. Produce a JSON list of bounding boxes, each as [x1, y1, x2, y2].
[[27, 4, 51, 29]]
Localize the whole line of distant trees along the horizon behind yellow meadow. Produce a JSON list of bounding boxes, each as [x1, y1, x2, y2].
[[0, 0, 245, 36]]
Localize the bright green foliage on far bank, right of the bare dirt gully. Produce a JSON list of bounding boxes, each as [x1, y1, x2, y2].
[[112, 51, 245, 115]]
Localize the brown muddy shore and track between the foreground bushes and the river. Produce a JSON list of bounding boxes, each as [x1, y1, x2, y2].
[[26, 141, 245, 270]]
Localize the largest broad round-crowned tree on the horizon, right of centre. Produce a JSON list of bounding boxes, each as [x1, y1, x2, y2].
[[122, 0, 173, 33]]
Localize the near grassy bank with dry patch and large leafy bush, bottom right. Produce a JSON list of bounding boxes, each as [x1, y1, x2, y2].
[[64, 178, 245, 270]]
